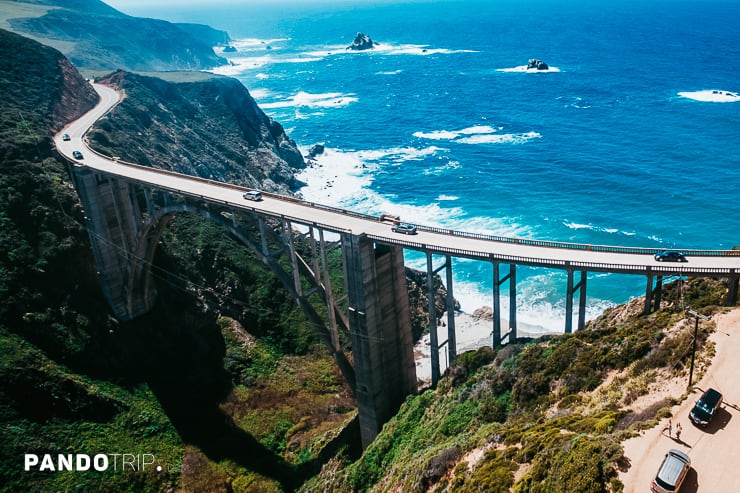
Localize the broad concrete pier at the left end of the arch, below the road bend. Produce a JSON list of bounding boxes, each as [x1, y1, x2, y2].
[[70, 165, 156, 320]]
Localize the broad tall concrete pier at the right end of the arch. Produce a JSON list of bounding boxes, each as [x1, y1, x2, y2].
[[342, 233, 416, 447]]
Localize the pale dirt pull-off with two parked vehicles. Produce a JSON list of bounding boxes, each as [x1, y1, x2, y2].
[[619, 309, 740, 493]]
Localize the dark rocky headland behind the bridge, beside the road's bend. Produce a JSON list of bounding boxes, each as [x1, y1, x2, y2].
[[89, 72, 305, 193]]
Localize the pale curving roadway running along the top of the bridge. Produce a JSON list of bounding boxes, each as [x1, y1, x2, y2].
[[54, 84, 740, 275]]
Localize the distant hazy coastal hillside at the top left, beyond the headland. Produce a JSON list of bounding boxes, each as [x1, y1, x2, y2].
[[1, 0, 229, 71]]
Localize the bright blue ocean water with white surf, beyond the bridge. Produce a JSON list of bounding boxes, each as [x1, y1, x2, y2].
[[115, 0, 740, 330]]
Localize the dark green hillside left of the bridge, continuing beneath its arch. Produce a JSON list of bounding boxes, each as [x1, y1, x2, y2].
[[0, 31, 355, 492]]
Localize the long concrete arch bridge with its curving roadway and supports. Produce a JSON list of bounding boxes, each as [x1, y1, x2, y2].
[[54, 84, 740, 446]]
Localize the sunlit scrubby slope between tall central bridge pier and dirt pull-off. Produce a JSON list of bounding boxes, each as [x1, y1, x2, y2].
[[302, 280, 725, 493]]
